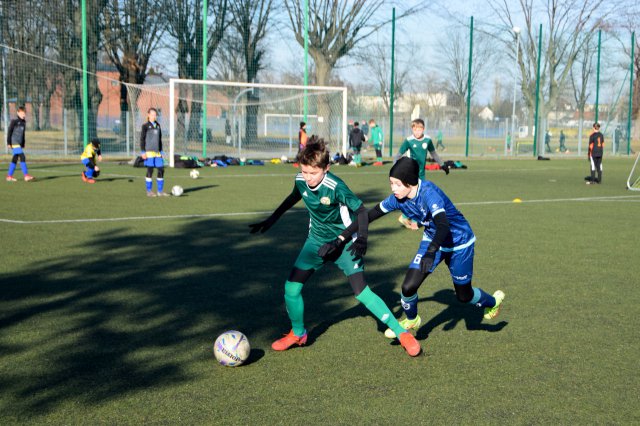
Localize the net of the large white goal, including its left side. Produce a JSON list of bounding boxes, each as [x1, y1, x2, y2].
[[128, 79, 347, 167]]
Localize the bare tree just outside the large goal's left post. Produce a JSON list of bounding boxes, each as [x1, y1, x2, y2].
[[102, 0, 166, 138]]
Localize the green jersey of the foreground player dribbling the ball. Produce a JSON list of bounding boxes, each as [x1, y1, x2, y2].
[[295, 173, 362, 243]]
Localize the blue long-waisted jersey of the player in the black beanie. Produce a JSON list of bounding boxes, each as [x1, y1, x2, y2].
[[380, 180, 476, 251]]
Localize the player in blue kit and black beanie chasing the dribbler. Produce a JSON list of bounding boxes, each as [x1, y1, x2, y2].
[[322, 157, 505, 338]]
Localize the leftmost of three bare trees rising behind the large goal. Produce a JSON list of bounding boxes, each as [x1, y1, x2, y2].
[[162, 0, 229, 138]]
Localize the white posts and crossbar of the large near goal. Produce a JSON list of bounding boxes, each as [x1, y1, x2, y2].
[[169, 78, 348, 167]]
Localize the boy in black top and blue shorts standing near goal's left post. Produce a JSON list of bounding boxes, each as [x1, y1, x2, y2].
[[140, 108, 169, 197]]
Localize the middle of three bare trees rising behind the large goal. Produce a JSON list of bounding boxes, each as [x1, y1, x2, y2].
[[229, 0, 274, 141]]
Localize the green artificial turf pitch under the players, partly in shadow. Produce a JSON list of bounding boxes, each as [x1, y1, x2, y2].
[[0, 158, 640, 424]]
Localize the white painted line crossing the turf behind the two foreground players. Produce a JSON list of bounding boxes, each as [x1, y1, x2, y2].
[[0, 195, 640, 225]]
